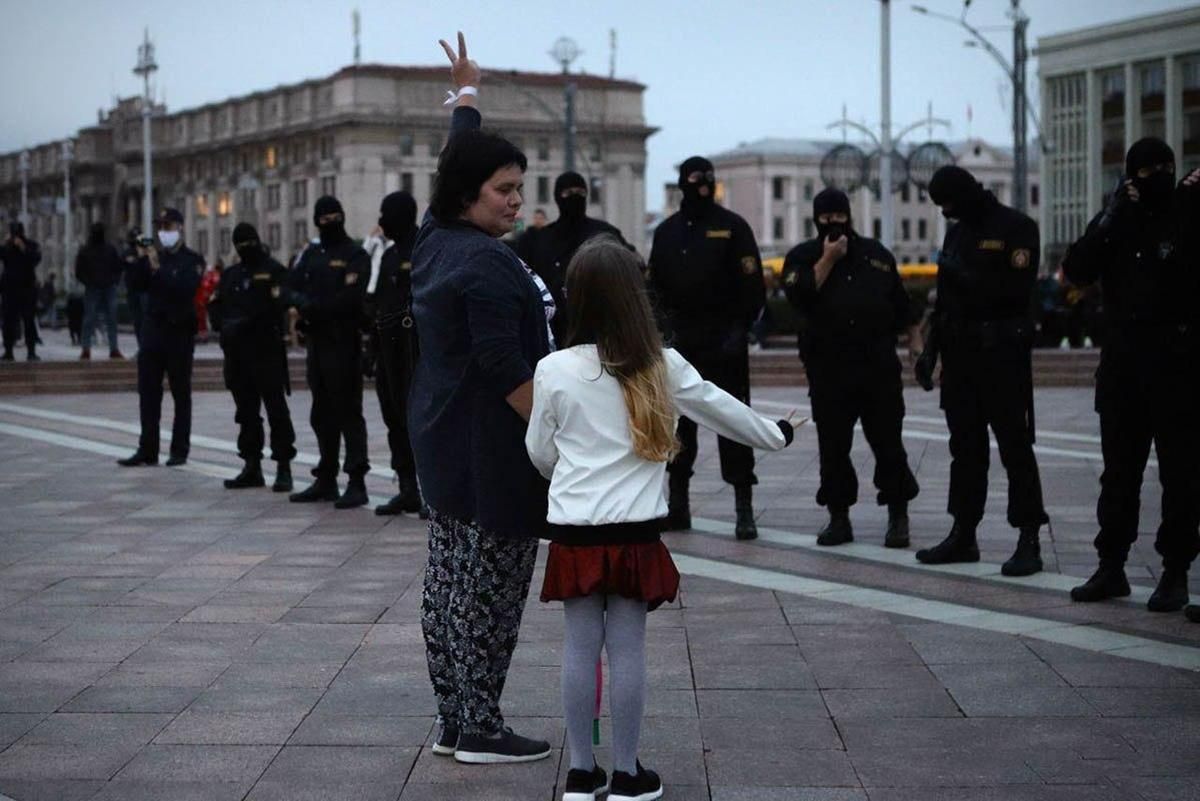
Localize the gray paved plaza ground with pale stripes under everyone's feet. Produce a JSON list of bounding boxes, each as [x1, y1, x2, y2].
[[0, 383, 1200, 801]]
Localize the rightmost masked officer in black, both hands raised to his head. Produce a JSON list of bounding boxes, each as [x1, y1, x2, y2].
[[1062, 138, 1200, 612]]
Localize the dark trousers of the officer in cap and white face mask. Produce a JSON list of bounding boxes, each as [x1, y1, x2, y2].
[[138, 327, 194, 459]]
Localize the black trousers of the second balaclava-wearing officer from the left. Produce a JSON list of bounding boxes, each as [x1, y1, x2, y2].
[[306, 336, 371, 481]]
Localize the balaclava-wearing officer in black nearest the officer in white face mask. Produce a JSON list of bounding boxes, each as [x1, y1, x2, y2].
[[208, 223, 296, 493]]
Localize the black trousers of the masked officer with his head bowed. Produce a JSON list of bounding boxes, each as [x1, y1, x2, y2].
[[942, 343, 1049, 528]]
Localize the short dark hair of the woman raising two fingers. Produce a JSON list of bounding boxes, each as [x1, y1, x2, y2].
[[430, 131, 528, 222]]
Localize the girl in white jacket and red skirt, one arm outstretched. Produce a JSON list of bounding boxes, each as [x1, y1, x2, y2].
[[526, 237, 803, 801]]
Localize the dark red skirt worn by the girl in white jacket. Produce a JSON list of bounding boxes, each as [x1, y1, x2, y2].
[[541, 542, 679, 609]]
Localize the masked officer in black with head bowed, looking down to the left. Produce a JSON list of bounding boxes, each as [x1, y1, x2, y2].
[[917, 165, 1049, 576]]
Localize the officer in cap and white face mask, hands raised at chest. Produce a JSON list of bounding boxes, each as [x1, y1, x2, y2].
[[118, 209, 204, 468]]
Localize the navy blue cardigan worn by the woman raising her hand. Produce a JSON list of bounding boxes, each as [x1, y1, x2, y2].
[[408, 109, 550, 538]]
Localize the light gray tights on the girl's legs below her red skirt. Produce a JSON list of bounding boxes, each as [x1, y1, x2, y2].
[[563, 595, 646, 773]]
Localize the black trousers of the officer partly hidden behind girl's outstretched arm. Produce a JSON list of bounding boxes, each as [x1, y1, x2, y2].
[[667, 339, 758, 487]]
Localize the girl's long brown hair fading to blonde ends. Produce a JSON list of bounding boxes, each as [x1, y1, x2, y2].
[[566, 236, 679, 462]]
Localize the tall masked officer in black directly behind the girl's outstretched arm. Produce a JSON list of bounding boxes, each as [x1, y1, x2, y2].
[[648, 156, 766, 540]]
